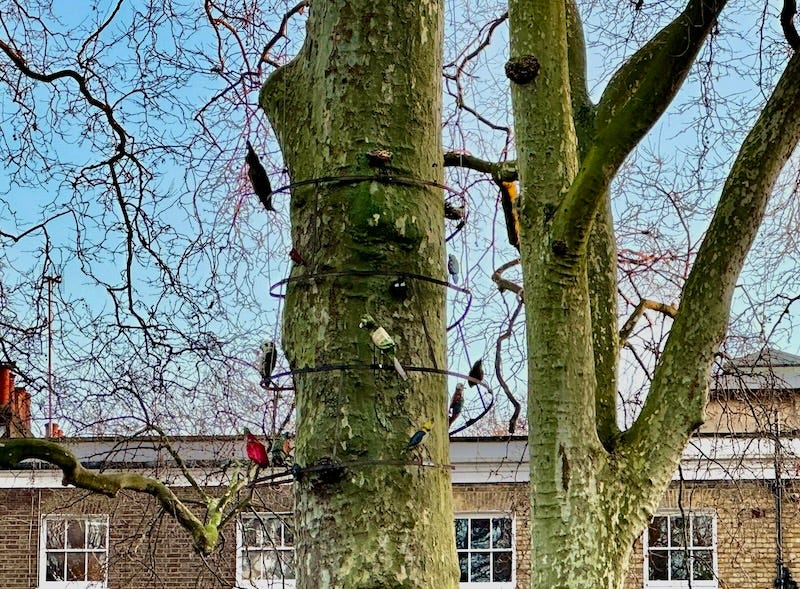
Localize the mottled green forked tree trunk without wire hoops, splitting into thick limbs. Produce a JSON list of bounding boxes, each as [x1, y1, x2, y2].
[[509, 0, 800, 589]]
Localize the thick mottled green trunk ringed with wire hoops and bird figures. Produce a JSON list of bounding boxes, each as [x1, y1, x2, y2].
[[261, 0, 457, 589]]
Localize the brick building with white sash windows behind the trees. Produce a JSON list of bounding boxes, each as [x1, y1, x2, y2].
[[0, 351, 800, 589]]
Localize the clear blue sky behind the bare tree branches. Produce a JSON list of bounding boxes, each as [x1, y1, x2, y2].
[[0, 1, 800, 432]]
